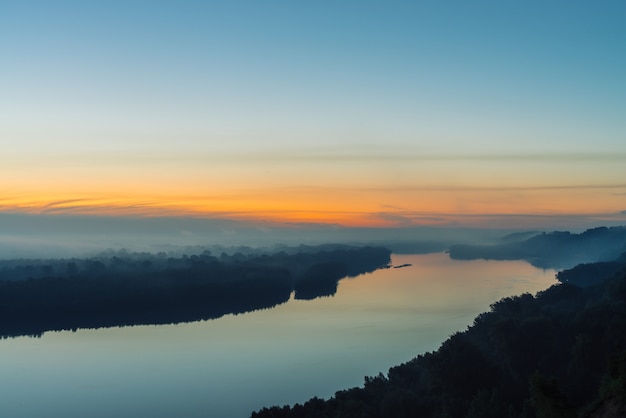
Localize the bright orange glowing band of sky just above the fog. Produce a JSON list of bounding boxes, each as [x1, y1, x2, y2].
[[0, 182, 621, 228]]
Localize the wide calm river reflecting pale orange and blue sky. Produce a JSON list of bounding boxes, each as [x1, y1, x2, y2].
[[0, 254, 556, 418]]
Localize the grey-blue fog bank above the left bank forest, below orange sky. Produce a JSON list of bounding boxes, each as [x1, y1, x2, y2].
[[0, 213, 611, 259]]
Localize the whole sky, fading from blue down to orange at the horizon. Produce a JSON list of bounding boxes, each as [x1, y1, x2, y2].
[[0, 0, 626, 235]]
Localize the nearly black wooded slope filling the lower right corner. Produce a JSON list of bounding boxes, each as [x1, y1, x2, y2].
[[252, 255, 626, 418]]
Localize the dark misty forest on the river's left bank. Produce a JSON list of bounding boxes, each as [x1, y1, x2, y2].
[[0, 246, 390, 337]]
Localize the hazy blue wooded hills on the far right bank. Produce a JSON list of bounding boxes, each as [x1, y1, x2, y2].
[[450, 226, 626, 268]]
